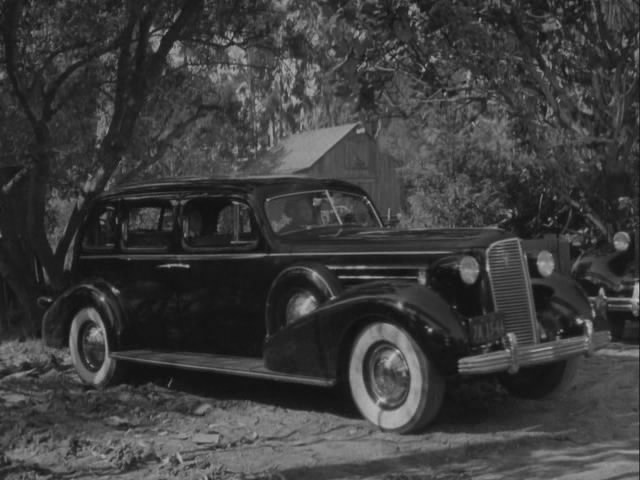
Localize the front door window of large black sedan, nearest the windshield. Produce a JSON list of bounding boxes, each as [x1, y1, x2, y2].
[[182, 197, 258, 249]]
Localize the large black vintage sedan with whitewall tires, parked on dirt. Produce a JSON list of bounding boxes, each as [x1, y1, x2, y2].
[[43, 177, 609, 433]]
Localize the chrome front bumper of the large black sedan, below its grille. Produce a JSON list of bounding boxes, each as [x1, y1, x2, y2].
[[458, 320, 611, 375]]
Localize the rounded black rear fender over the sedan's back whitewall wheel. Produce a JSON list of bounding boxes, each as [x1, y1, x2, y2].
[[42, 280, 125, 348]]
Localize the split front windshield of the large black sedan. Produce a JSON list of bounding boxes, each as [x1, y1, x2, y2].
[[264, 188, 384, 236]]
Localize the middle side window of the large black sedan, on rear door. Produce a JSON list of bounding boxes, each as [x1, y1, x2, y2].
[[122, 200, 175, 250]]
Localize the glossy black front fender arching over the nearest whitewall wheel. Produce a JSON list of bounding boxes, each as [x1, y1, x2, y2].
[[265, 282, 468, 379]]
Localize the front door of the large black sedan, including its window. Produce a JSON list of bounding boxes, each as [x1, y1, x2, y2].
[[180, 196, 275, 356]]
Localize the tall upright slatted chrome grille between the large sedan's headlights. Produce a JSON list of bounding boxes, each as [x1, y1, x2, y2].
[[487, 238, 538, 345]]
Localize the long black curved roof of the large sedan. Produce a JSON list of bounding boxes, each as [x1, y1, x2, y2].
[[100, 175, 364, 199]]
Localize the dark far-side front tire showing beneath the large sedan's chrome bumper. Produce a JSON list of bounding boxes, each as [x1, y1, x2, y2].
[[500, 357, 580, 400]]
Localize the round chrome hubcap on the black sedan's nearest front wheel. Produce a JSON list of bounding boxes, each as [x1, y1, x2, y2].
[[363, 342, 411, 410]]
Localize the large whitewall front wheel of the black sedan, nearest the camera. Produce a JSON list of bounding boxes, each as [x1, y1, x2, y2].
[[349, 322, 445, 433]]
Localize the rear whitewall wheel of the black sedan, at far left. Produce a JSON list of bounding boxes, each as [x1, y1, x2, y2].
[[69, 307, 122, 388]]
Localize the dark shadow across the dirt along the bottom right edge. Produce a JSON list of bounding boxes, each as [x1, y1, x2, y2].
[[280, 439, 638, 480]]
